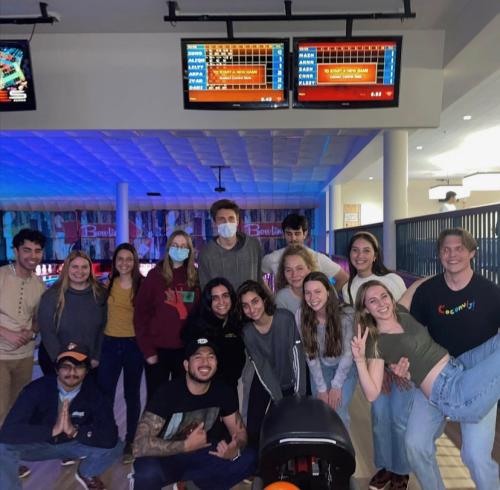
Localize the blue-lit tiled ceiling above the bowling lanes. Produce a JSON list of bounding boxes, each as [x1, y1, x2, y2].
[[0, 129, 376, 210]]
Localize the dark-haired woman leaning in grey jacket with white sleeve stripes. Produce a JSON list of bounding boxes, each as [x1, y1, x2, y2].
[[236, 281, 306, 446]]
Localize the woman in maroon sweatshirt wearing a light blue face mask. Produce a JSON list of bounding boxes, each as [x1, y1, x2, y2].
[[134, 230, 200, 400]]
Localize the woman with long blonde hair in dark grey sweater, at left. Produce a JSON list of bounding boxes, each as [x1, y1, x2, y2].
[[38, 250, 106, 374]]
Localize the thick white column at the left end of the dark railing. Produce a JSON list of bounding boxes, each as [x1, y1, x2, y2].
[[384, 129, 408, 269]]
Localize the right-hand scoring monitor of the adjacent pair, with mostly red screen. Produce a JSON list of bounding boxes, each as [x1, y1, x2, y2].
[[293, 36, 402, 109]]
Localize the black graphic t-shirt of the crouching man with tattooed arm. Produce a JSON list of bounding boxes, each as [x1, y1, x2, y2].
[[146, 376, 238, 442]]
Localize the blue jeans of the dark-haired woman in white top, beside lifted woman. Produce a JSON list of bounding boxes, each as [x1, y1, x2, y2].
[[371, 382, 416, 475]]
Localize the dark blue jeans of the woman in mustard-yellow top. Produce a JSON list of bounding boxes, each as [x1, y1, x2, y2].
[[98, 335, 144, 443]]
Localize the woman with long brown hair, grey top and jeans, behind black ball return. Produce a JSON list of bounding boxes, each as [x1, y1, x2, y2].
[[295, 272, 356, 429]]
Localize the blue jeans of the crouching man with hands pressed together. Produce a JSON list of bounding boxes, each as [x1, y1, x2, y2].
[[0, 441, 123, 490]]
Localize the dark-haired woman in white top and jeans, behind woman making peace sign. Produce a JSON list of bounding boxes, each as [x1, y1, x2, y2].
[[342, 231, 415, 490]]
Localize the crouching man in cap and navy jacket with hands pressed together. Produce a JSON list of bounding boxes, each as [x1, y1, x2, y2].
[[0, 344, 123, 490]]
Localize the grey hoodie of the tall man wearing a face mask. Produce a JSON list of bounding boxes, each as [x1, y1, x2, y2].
[[198, 232, 262, 289]]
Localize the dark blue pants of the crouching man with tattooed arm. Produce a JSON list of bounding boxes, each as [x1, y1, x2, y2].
[[132, 444, 257, 490]]
